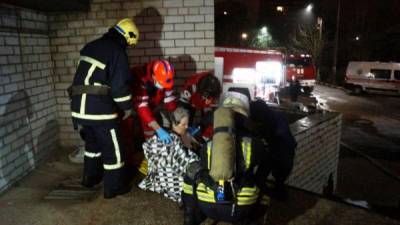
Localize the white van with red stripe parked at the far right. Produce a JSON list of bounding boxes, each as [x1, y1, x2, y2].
[[345, 61, 400, 94]]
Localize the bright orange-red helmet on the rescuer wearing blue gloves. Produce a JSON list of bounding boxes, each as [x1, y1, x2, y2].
[[148, 60, 174, 89]]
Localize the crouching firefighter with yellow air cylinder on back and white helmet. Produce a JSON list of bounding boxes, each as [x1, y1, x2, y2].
[[182, 92, 269, 225]]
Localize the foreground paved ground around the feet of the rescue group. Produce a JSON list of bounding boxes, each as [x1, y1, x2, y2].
[[0, 151, 400, 225]]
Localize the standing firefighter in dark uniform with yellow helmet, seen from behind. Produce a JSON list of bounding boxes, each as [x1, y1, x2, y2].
[[68, 18, 139, 198]]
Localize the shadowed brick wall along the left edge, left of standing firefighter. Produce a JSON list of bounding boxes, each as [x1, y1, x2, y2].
[[0, 4, 58, 192]]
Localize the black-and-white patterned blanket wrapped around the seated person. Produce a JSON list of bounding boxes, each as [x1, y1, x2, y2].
[[139, 133, 199, 202]]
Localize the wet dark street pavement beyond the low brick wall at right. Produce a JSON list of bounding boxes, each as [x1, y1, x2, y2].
[[313, 86, 400, 216]]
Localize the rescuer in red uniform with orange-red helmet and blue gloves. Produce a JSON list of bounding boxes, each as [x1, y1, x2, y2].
[[131, 60, 177, 144]]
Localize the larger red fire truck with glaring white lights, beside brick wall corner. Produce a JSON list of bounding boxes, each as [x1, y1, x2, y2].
[[215, 47, 286, 103]]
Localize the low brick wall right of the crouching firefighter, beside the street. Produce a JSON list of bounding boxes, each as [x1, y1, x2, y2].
[[288, 113, 342, 194]]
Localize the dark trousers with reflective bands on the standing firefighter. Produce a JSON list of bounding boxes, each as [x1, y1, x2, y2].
[[81, 124, 127, 194]]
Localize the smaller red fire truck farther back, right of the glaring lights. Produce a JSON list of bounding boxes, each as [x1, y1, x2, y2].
[[286, 54, 317, 92]]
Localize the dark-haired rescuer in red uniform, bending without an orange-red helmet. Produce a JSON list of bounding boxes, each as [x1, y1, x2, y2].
[[178, 71, 222, 139]]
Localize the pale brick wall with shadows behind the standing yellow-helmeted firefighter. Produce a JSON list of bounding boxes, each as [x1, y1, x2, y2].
[[49, 0, 214, 146]]
